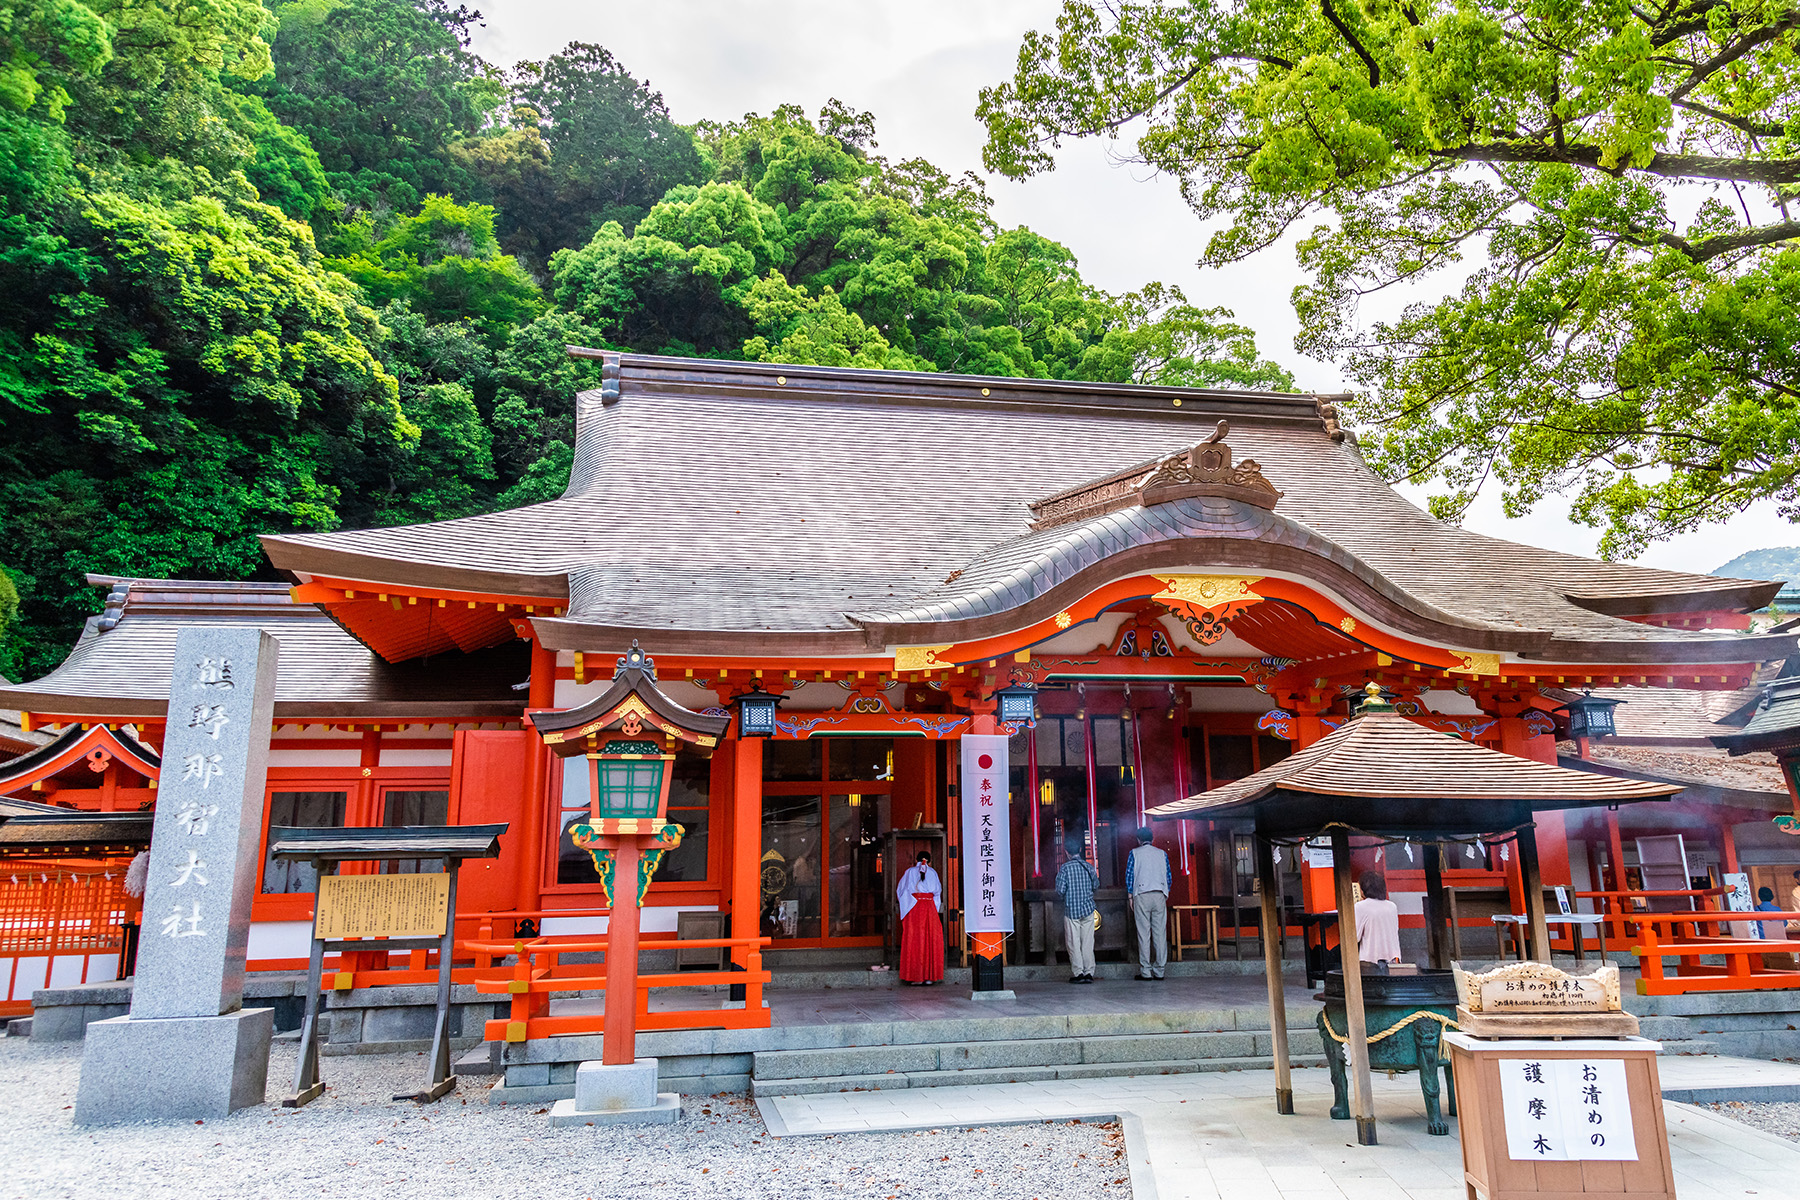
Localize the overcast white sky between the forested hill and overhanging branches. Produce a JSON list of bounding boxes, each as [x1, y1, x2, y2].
[[475, 0, 1800, 570]]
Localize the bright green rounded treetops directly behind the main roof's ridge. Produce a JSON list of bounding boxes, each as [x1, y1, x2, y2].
[[551, 101, 1292, 387]]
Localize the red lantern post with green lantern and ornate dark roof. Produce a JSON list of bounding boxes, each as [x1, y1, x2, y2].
[[531, 640, 731, 1085]]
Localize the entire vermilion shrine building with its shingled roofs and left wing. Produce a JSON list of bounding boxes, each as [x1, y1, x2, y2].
[[0, 351, 1800, 985]]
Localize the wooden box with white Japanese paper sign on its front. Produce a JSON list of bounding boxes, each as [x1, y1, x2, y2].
[[1444, 1033, 1676, 1200]]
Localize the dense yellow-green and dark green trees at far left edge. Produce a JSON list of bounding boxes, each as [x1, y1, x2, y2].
[[0, 4, 418, 675]]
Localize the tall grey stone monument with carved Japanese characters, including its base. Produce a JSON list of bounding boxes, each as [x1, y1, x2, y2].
[[76, 626, 277, 1124]]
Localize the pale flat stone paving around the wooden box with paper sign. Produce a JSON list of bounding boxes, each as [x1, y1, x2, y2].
[[758, 1056, 1800, 1200]]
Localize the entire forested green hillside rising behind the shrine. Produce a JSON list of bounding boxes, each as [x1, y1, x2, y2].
[[0, 0, 1292, 678]]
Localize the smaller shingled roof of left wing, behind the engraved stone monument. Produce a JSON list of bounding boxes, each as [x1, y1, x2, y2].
[[0, 576, 529, 723]]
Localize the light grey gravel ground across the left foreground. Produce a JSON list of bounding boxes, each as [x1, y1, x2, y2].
[[0, 1038, 1130, 1200]]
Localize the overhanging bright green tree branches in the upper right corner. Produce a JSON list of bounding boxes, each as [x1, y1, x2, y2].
[[979, 0, 1800, 554]]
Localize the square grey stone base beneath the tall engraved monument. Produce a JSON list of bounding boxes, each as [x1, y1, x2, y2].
[[76, 1007, 275, 1124]]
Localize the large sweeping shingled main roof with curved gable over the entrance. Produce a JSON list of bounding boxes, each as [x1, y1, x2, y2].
[[243, 354, 1795, 662]]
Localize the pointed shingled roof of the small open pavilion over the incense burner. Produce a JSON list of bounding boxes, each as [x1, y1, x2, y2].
[[1150, 711, 1681, 831]]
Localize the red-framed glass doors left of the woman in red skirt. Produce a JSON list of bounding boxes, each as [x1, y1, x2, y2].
[[761, 738, 895, 948]]
